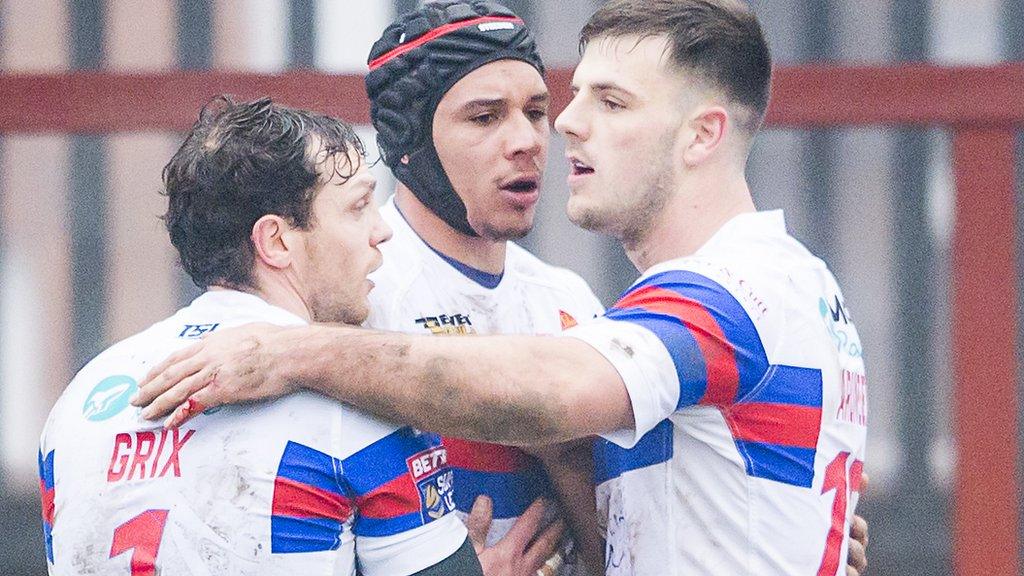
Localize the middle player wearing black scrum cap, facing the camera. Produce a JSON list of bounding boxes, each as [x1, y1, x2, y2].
[[366, 0, 604, 575]]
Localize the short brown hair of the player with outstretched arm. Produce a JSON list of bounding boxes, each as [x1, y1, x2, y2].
[[580, 0, 771, 133]]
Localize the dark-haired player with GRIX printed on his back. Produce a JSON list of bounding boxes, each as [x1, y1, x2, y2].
[[39, 98, 482, 576]]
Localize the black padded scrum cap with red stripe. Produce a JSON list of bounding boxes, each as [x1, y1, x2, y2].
[[366, 0, 544, 236]]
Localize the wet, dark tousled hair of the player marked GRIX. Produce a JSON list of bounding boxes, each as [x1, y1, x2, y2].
[[163, 95, 365, 288]]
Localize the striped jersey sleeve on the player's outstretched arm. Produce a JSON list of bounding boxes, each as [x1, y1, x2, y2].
[[566, 270, 768, 448]]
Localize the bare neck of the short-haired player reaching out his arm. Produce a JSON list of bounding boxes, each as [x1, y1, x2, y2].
[[623, 168, 757, 273]]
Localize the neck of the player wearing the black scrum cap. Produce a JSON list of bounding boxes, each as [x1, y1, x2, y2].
[[394, 183, 507, 274]]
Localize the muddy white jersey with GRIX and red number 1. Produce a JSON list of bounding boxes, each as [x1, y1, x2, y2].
[[39, 290, 466, 576]]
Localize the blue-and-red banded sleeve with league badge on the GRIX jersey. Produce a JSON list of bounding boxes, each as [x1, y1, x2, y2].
[[341, 427, 467, 576]]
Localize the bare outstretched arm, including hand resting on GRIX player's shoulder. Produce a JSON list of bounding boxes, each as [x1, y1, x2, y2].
[[135, 324, 634, 445]]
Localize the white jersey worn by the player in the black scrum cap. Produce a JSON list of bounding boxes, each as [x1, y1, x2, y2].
[[367, 198, 604, 544]]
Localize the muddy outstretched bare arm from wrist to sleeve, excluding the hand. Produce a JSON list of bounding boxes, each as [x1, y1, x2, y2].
[[286, 326, 632, 445]]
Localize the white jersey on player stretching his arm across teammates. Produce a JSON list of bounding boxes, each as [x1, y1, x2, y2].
[[566, 211, 867, 576]]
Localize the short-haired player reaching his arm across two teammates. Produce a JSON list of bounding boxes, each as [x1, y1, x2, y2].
[[139, 0, 866, 574]]
